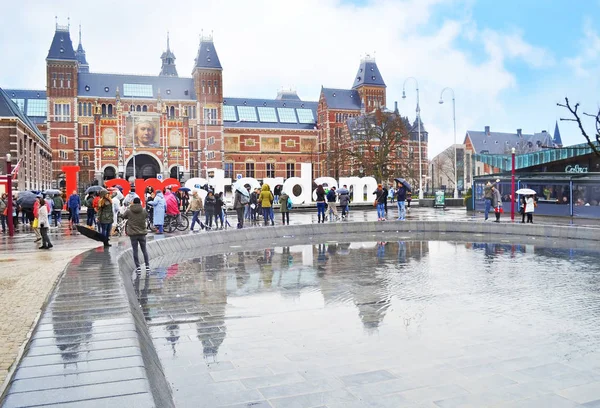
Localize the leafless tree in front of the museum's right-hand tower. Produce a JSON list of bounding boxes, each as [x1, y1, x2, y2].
[[344, 109, 408, 181]]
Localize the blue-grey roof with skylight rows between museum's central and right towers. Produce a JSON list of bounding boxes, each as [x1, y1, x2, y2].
[[223, 97, 319, 130]]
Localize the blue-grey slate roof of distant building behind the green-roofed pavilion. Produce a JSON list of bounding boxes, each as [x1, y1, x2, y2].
[[467, 130, 552, 154]]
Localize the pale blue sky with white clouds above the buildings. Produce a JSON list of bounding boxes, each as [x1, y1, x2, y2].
[[0, 0, 600, 158]]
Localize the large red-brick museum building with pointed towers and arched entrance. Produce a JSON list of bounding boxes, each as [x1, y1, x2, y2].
[[5, 25, 428, 188]]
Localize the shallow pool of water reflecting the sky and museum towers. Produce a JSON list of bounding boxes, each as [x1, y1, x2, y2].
[[135, 241, 600, 408]]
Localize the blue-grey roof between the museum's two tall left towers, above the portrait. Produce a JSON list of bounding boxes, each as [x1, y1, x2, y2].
[[77, 73, 196, 101]]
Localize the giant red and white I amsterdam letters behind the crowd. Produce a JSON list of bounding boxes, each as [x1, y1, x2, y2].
[[62, 163, 377, 205]]
